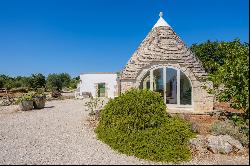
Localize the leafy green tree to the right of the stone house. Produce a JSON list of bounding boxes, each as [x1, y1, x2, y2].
[[191, 39, 249, 113]]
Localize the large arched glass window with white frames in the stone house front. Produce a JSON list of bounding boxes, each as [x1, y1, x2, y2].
[[139, 67, 192, 105]]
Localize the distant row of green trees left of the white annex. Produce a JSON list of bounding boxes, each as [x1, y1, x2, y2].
[[0, 73, 80, 90]]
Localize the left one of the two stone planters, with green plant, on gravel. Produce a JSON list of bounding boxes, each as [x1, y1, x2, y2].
[[17, 93, 33, 111]]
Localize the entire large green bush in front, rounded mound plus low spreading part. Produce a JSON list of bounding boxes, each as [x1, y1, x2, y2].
[[96, 89, 194, 162]]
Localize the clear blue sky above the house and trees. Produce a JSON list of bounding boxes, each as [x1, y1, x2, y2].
[[0, 0, 249, 76]]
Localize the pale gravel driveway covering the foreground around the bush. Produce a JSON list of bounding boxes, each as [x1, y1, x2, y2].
[[0, 99, 249, 165]]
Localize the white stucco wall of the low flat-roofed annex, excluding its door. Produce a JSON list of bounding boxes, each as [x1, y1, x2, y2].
[[79, 73, 117, 98]]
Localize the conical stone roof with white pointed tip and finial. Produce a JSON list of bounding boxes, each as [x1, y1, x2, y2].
[[121, 12, 207, 81]]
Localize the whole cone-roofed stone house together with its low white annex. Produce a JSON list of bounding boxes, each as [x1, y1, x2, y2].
[[77, 12, 213, 113]]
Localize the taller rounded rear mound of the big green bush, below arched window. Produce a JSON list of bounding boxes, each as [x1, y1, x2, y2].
[[97, 90, 167, 131]]
